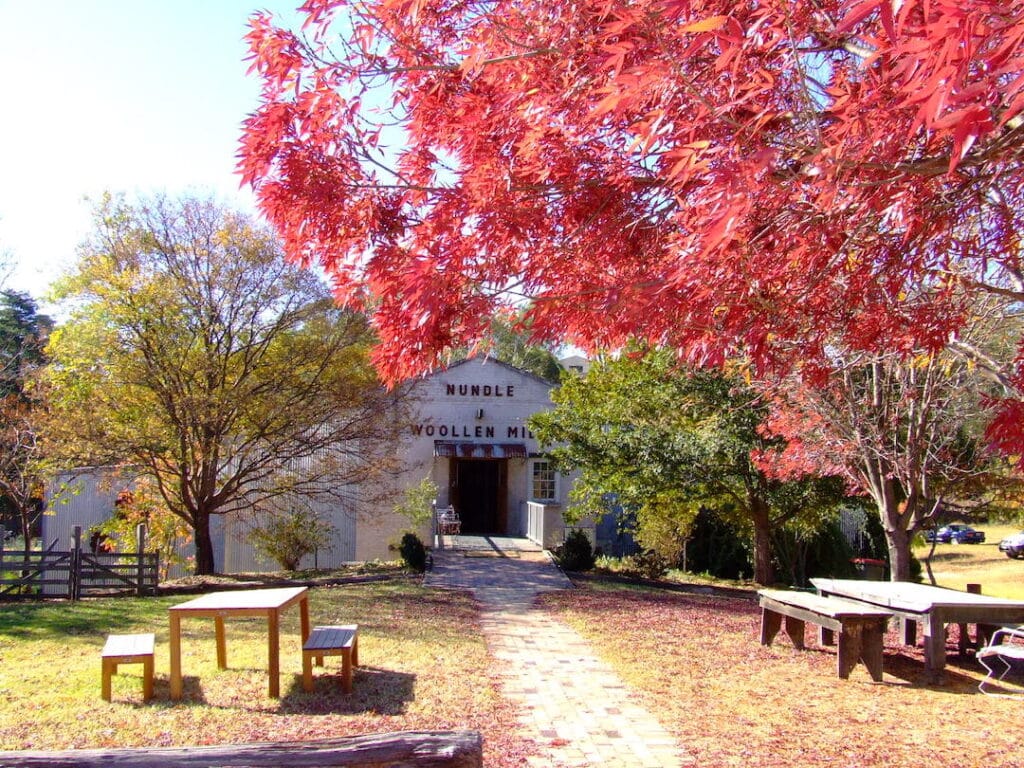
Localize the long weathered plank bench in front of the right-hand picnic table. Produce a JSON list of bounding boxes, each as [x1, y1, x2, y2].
[[758, 590, 893, 682]]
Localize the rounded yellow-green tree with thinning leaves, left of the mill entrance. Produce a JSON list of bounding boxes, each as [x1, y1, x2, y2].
[[48, 198, 400, 573]]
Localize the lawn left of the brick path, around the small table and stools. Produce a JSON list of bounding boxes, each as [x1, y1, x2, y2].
[[0, 581, 531, 766]]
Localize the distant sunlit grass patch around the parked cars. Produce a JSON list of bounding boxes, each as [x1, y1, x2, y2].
[[914, 524, 1024, 600]]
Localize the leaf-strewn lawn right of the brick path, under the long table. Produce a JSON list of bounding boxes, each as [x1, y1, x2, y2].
[[542, 582, 1024, 768]]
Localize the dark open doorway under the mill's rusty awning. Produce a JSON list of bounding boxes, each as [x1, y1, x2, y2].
[[449, 459, 508, 536]]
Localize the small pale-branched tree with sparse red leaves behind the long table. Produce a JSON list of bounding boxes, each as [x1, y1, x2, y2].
[[756, 350, 1007, 581]]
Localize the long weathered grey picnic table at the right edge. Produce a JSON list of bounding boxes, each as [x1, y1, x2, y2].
[[811, 579, 1024, 678]]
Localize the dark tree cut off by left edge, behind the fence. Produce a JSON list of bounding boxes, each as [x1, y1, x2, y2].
[[0, 291, 53, 550]]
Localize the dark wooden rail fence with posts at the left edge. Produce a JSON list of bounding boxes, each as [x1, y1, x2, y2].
[[0, 525, 160, 600]]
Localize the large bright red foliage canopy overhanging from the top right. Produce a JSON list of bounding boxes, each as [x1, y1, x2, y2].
[[240, 0, 1024, 449]]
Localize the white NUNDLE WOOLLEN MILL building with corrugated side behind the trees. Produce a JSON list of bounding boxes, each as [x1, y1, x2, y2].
[[43, 357, 570, 572]]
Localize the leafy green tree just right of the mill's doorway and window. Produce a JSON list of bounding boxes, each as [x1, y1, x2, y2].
[[530, 350, 842, 584]]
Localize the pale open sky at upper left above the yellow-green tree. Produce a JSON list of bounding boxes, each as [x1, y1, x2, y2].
[[0, 0, 299, 300]]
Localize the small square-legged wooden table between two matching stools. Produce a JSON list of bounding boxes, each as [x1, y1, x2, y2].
[[168, 587, 309, 700]]
